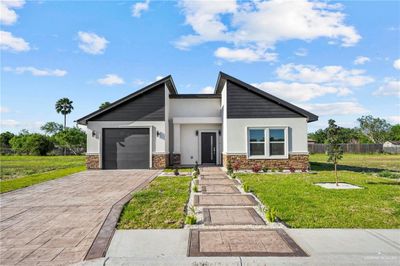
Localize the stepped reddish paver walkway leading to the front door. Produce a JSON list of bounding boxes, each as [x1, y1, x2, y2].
[[188, 167, 306, 256]]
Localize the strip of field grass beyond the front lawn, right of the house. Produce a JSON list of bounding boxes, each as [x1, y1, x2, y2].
[[310, 153, 400, 172]]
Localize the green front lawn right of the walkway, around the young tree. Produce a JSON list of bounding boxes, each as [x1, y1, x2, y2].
[[239, 171, 400, 228]]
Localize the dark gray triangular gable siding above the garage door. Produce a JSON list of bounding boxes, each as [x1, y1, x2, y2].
[[89, 84, 165, 121]]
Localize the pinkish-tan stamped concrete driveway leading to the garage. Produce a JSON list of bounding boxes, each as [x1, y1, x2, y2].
[[0, 170, 158, 265]]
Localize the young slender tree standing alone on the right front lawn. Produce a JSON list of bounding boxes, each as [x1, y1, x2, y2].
[[327, 119, 343, 186]]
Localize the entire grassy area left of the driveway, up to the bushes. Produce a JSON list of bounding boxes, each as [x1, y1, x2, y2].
[[0, 155, 85, 193]]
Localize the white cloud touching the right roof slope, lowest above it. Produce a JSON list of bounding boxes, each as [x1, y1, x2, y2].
[[252, 81, 351, 102]]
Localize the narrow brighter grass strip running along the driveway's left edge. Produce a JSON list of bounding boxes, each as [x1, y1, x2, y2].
[[0, 166, 85, 193]]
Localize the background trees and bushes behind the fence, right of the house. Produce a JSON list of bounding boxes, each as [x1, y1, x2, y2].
[[308, 115, 400, 143]]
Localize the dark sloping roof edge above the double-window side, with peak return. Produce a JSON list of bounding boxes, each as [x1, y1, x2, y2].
[[214, 72, 318, 122]]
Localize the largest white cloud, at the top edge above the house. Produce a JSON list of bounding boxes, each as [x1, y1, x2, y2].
[[175, 0, 361, 61]]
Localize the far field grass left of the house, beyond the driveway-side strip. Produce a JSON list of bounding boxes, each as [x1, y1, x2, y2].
[[0, 155, 85, 180]]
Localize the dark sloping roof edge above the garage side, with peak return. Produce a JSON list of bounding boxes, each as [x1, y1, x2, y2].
[[77, 75, 178, 125]]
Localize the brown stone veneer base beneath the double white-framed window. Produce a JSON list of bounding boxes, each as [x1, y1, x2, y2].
[[223, 154, 309, 170]]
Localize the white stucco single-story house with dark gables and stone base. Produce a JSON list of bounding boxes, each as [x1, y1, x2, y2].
[[78, 72, 318, 169]]
